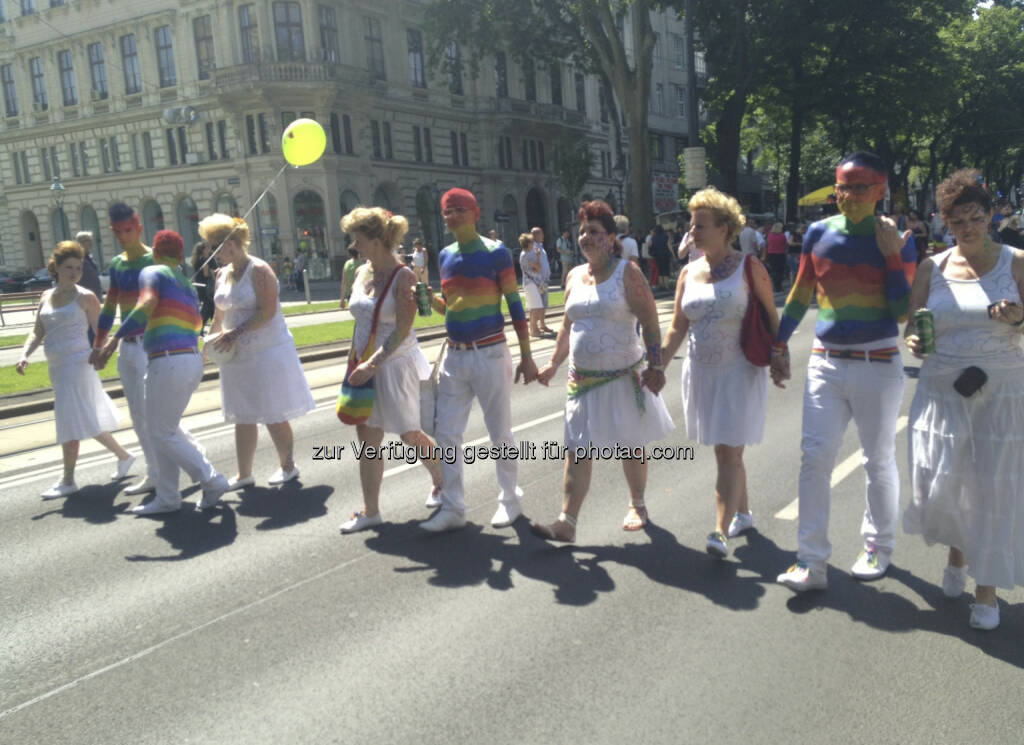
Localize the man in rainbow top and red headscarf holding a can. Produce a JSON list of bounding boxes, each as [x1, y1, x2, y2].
[[421, 188, 537, 532]]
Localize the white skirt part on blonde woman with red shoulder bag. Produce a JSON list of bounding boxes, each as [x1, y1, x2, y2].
[[683, 356, 768, 447]]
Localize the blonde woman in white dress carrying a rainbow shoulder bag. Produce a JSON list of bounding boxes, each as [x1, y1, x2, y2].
[[341, 207, 441, 533]]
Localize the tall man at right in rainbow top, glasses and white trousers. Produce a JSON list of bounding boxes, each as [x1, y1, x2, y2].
[[771, 151, 916, 591]]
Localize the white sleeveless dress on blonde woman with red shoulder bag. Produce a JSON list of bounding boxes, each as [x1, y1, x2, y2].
[[680, 256, 768, 447]]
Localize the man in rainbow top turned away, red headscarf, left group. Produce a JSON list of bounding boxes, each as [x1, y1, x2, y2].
[[100, 230, 227, 515]]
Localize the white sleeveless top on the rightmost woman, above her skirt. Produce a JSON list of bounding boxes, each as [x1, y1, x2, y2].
[[921, 246, 1024, 377]]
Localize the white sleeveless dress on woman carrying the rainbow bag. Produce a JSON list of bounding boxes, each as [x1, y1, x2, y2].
[[348, 269, 430, 435]]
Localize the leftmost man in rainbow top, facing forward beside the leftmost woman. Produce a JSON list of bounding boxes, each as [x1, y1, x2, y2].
[[89, 202, 157, 494]]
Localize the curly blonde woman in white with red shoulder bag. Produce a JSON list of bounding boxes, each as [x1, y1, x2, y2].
[[664, 187, 785, 558]]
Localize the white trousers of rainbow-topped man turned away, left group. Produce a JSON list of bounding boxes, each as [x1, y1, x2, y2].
[[145, 354, 218, 503]]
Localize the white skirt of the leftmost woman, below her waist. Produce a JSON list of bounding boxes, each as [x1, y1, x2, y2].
[[49, 350, 121, 443]]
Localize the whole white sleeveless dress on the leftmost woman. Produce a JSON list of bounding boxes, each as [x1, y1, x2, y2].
[[39, 288, 121, 443]]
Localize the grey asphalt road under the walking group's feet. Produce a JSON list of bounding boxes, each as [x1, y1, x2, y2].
[[0, 317, 1024, 745]]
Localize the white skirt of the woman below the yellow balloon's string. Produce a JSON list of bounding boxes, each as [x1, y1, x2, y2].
[[220, 334, 316, 425]]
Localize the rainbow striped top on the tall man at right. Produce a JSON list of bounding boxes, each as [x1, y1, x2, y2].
[[778, 215, 918, 345]]
